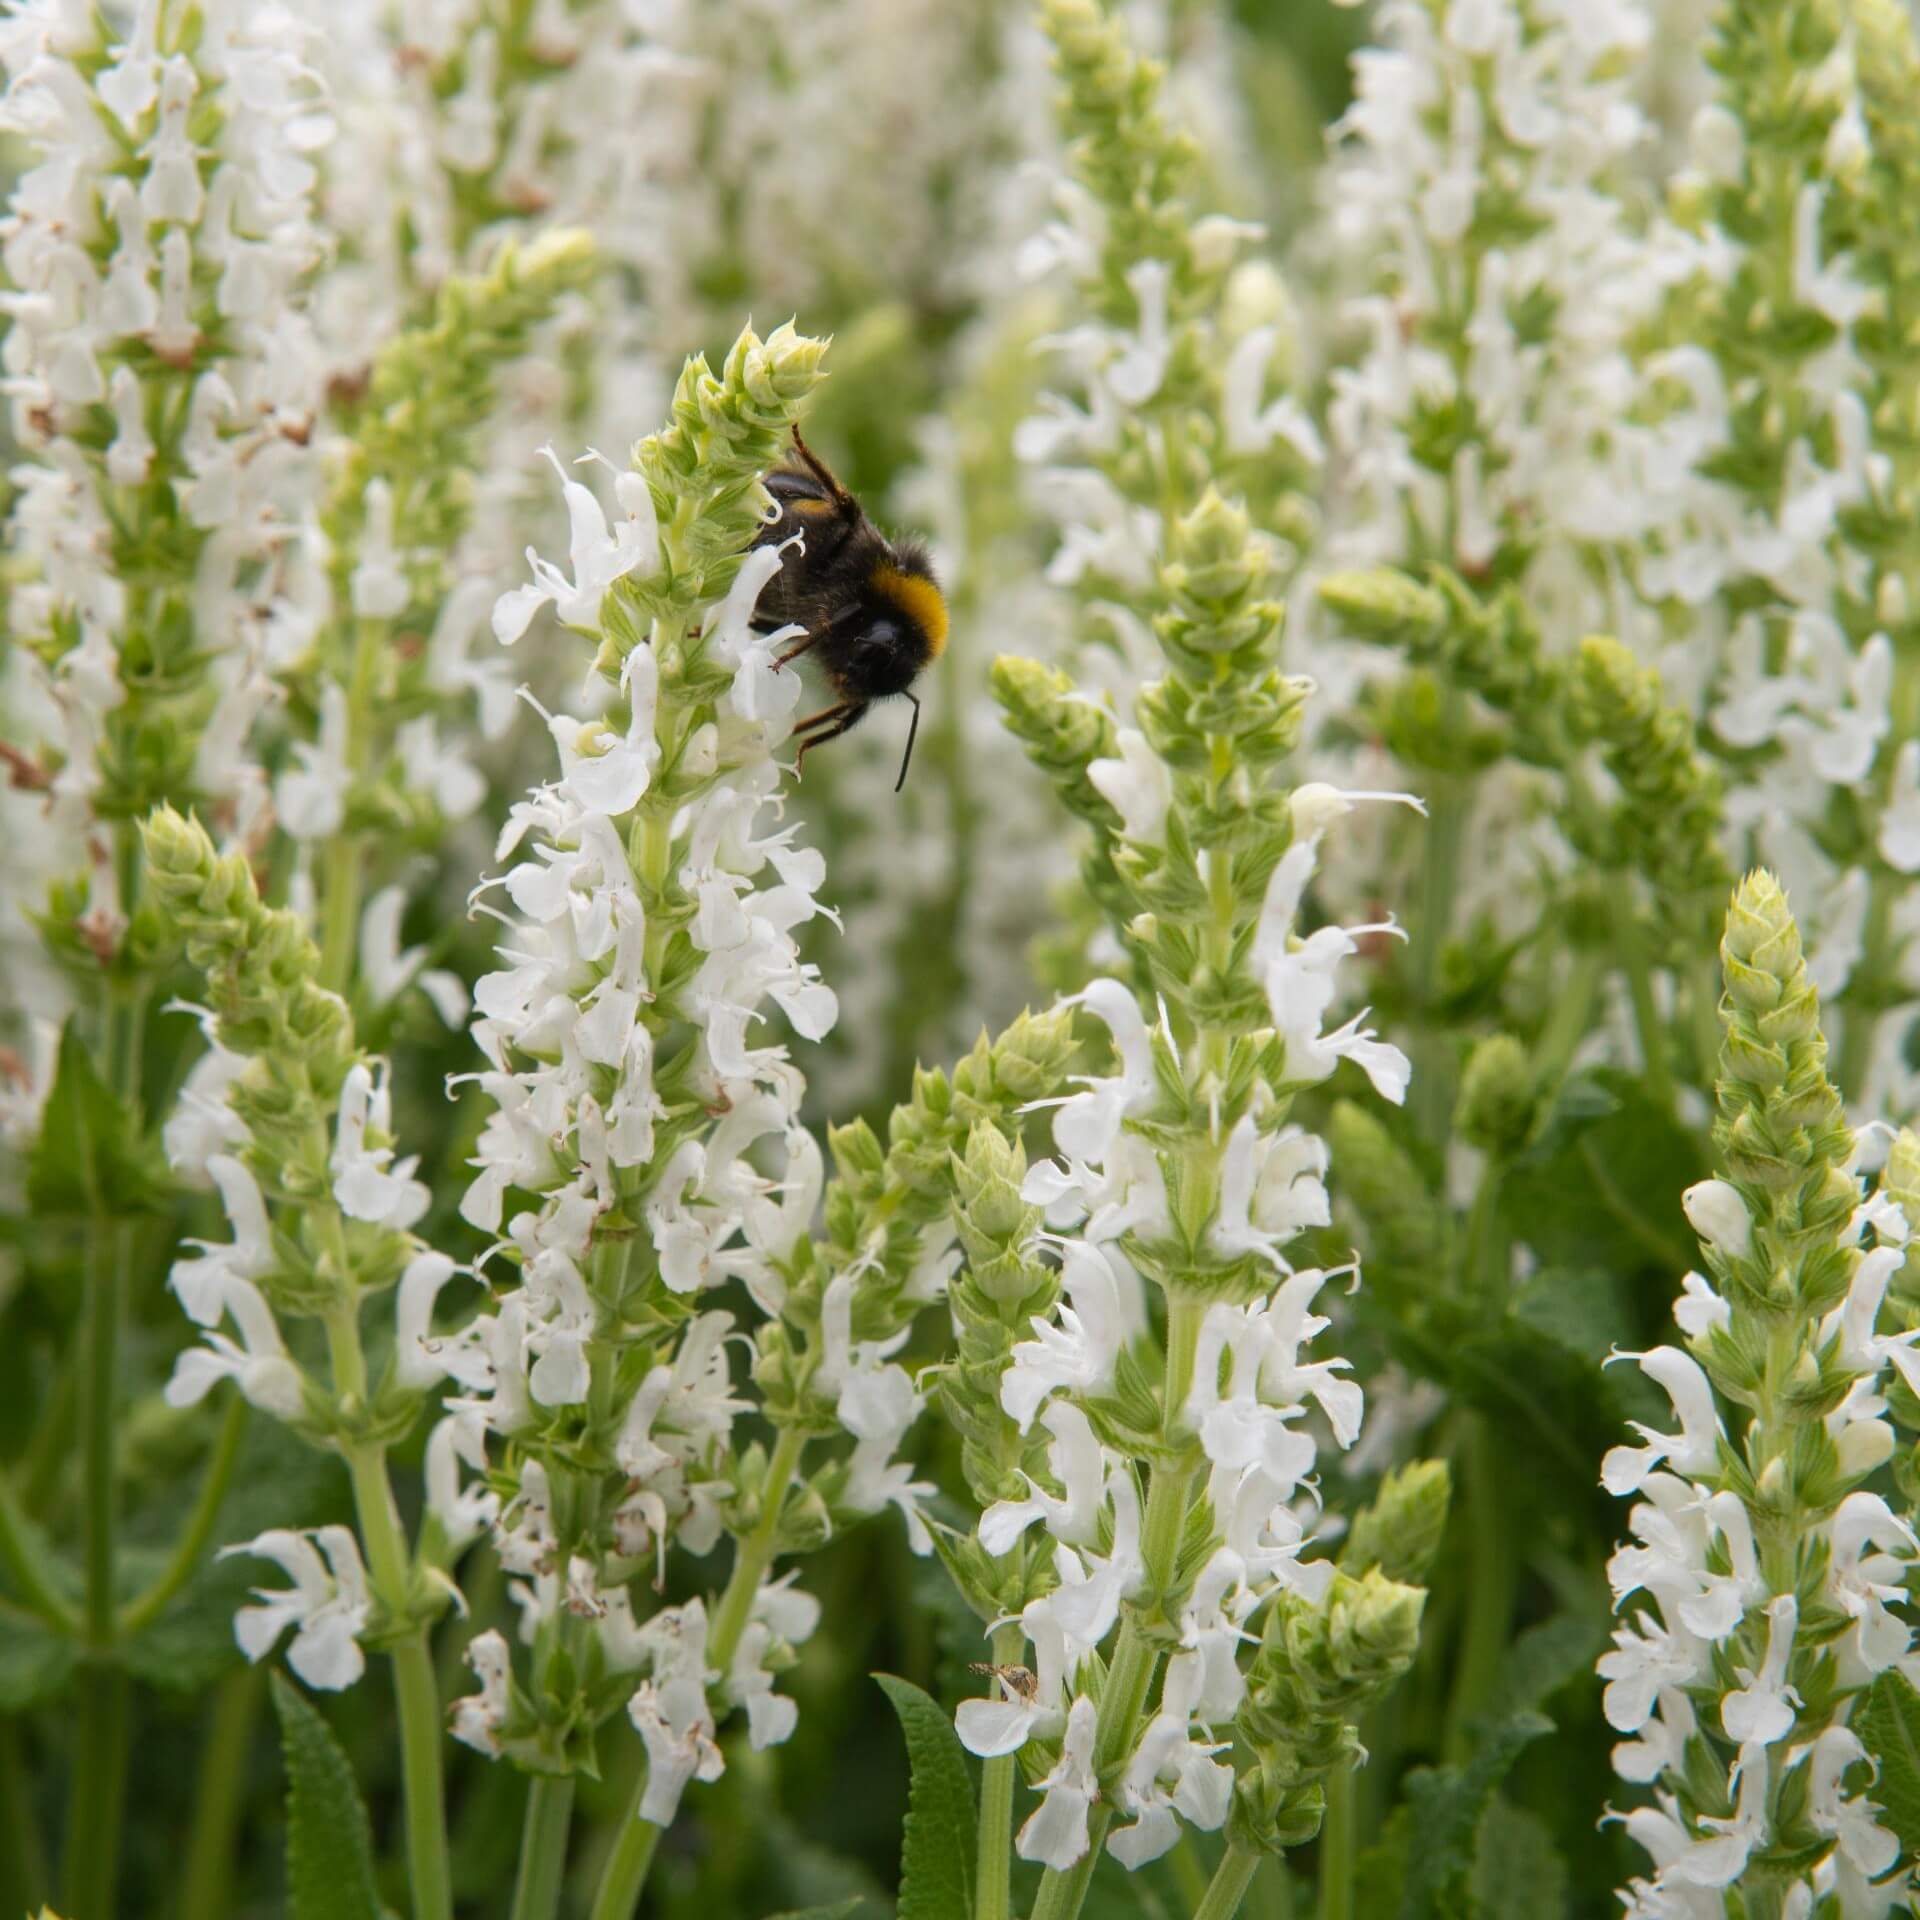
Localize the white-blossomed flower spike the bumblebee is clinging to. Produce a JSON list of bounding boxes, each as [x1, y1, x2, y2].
[[432, 328, 894, 1824]]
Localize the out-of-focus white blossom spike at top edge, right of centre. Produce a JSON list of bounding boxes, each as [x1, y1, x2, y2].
[[1321, 0, 1665, 606]]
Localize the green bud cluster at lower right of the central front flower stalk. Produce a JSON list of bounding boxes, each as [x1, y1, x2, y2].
[[1227, 1567, 1427, 1853]]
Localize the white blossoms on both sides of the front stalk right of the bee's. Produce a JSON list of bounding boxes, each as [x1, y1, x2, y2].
[[956, 837, 1407, 1870]]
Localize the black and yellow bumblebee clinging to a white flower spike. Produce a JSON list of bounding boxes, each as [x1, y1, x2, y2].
[[753, 428, 947, 793]]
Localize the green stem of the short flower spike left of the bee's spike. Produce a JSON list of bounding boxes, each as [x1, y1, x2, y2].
[[326, 1290, 453, 1920]]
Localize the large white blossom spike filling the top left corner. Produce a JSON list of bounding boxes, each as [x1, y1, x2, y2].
[[0, 0, 332, 990]]
